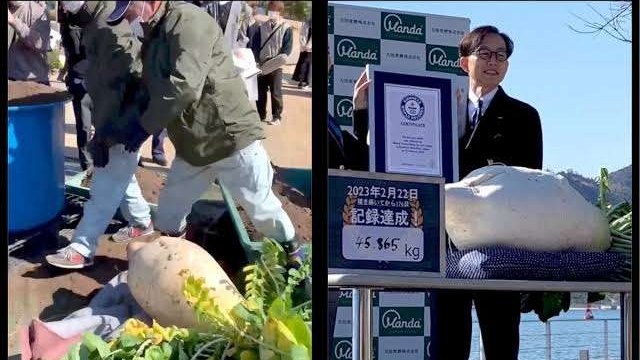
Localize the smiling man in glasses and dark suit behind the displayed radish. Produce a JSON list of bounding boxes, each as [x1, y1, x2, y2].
[[436, 26, 542, 360]]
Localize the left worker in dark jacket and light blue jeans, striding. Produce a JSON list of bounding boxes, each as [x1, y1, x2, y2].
[[46, 1, 153, 269]]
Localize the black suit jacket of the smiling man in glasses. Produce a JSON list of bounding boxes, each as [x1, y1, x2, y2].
[[458, 87, 542, 179]]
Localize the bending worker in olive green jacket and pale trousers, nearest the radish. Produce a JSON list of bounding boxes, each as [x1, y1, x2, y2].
[[104, 1, 305, 262]]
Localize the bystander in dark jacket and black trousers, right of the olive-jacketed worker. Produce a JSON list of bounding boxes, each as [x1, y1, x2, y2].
[[249, 1, 293, 125]]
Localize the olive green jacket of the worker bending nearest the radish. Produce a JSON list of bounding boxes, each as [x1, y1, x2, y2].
[[140, 2, 264, 166]]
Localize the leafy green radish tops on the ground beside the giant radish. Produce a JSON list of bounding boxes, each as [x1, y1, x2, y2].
[[64, 239, 311, 360]]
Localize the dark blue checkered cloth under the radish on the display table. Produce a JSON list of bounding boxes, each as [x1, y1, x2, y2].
[[447, 247, 625, 281]]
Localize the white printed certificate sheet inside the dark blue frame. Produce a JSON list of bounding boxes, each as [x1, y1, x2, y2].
[[384, 84, 442, 176]]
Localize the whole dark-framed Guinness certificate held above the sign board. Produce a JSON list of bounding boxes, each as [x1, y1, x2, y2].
[[367, 66, 458, 183]]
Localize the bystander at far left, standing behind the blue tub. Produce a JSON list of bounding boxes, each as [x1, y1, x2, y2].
[[7, 1, 51, 85]]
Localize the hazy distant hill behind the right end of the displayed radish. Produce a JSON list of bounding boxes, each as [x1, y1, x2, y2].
[[558, 165, 631, 205]]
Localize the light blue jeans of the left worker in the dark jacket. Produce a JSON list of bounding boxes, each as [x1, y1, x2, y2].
[[71, 144, 151, 258]]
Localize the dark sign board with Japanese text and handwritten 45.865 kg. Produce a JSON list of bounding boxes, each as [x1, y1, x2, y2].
[[328, 169, 444, 277]]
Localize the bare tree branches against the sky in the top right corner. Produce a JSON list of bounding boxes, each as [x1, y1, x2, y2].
[[569, 1, 632, 43]]
